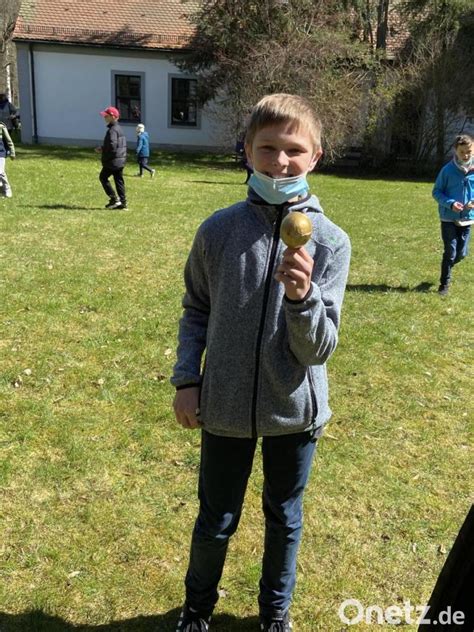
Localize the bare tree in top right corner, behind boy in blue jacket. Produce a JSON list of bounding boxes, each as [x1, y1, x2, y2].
[[397, 0, 474, 164]]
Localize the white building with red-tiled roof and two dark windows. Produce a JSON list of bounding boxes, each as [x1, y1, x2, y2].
[[14, 0, 228, 150]]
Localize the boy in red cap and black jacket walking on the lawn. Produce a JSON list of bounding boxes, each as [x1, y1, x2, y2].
[[96, 106, 128, 211]]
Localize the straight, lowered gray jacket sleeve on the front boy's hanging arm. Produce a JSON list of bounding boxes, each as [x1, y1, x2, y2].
[[171, 229, 210, 387]]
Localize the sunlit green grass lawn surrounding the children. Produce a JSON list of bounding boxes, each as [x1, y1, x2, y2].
[[0, 147, 474, 632]]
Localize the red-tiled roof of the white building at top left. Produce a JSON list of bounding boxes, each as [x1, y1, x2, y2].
[[14, 0, 197, 50]]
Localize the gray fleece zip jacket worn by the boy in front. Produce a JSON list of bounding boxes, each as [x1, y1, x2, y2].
[[171, 189, 350, 437]]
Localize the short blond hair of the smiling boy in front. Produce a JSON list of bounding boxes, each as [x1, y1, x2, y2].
[[245, 93, 321, 150]]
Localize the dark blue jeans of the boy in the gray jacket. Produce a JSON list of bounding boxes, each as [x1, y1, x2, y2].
[[185, 431, 316, 616]]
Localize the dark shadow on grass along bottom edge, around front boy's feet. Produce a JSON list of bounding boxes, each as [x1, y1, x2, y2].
[[0, 608, 258, 632]]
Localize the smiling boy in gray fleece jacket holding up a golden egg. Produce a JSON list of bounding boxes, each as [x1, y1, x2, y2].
[[171, 94, 350, 632]]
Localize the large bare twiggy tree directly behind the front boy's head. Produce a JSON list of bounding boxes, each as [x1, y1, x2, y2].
[[177, 0, 374, 160]]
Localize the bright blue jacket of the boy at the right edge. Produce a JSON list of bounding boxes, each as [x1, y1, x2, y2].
[[433, 160, 474, 222]]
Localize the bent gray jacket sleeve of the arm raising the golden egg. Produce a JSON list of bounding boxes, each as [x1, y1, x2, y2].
[[284, 234, 351, 366]]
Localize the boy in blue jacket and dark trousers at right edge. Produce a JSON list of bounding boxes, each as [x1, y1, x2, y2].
[[433, 134, 474, 296]]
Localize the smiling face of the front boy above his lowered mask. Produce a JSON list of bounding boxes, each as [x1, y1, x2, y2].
[[245, 123, 322, 178]]
